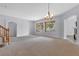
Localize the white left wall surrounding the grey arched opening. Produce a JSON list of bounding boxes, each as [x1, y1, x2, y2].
[[0, 15, 31, 36]]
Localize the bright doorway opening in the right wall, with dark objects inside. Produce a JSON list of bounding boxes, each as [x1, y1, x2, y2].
[[64, 16, 77, 40]]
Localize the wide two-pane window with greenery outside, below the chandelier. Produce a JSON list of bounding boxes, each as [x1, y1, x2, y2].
[[36, 21, 55, 32]]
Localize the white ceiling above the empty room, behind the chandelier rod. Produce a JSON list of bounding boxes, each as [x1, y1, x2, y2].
[[0, 3, 78, 20]]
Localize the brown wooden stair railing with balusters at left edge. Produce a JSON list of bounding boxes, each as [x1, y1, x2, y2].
[[0, 25, 10, 44]]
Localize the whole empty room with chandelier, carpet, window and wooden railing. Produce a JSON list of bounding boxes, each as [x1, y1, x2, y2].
[[0, 3, 79, 56]]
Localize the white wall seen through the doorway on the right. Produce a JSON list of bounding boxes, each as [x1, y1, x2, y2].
[[64, 16, 77, 39]]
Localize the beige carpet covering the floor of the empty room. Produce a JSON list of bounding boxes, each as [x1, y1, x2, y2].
[[0, 37, 79, 56]]
